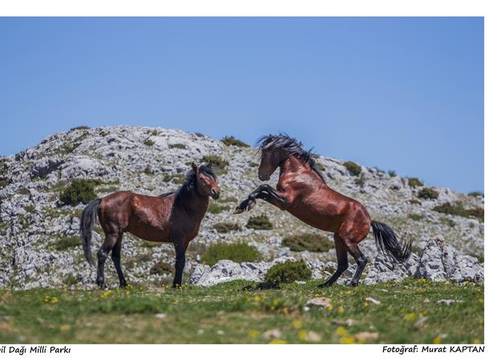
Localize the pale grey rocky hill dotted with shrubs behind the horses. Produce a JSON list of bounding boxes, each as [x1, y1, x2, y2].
[[0, 126, 484, 288]]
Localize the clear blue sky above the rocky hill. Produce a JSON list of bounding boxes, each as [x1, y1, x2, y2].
[[0, 18, 484, 192]]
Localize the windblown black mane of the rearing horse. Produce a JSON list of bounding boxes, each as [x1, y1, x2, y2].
[[257, 134, 326, 182]]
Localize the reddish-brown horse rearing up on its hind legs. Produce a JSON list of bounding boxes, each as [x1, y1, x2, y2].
[[235, 135, 411, 287]]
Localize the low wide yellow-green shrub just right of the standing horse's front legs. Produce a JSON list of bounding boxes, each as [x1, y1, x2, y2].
[[201, 243, 262, 266]]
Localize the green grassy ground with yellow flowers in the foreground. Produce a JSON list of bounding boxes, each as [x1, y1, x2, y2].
[[0, 280, 484, 343]]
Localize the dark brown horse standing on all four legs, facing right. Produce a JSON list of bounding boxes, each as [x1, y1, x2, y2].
[[80, 164, 220, 288]]
